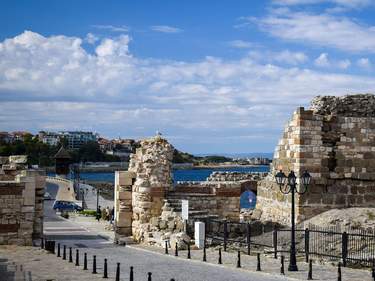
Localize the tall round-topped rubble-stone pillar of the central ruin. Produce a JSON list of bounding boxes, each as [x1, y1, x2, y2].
[[128, 136, 174, 241]]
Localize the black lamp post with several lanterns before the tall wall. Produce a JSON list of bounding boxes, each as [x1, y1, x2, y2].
[[275, 170, 311, 271]]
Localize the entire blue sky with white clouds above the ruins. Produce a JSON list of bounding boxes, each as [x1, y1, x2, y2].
[[0, 0, 375, 154]]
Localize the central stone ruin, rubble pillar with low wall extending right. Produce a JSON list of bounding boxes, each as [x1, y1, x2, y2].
[[115, 136, 262, 244]]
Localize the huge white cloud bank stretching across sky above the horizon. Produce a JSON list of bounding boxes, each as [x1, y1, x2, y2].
[[0, 31, 375, 152]]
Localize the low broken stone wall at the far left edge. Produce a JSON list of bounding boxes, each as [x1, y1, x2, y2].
[[0, 155, 45, 246]]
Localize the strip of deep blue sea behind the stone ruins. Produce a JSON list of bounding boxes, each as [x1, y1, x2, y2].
[[49, 166, 269, 183]]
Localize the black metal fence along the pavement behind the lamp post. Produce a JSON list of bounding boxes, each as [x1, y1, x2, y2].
[[205, 219, 375, 267]]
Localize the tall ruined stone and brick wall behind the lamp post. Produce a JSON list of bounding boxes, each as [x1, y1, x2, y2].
[[257, 95, 375, 223]]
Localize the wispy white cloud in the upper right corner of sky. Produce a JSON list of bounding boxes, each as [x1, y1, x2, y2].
[[256, 9, 375, 53]]
